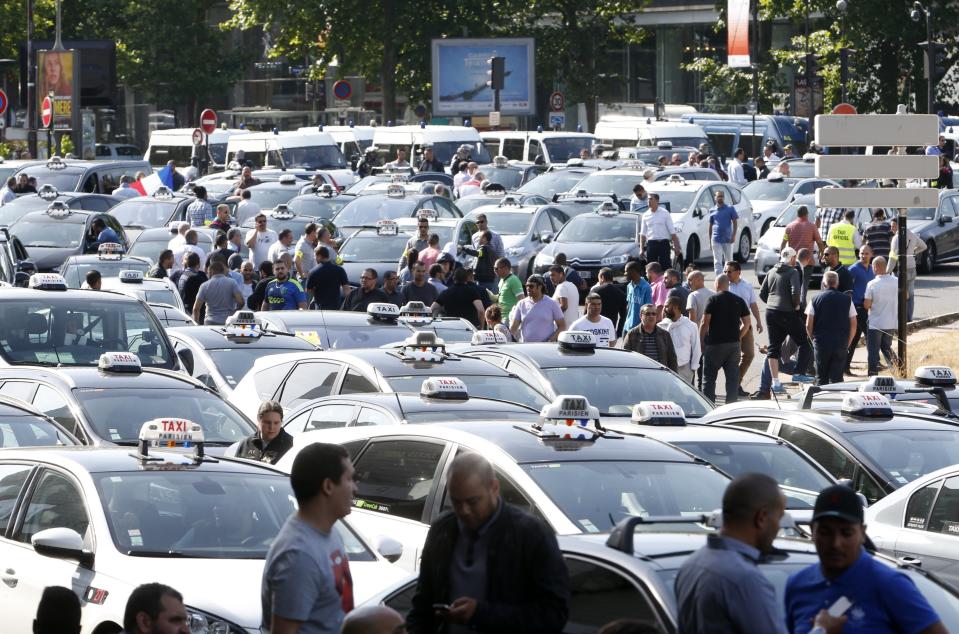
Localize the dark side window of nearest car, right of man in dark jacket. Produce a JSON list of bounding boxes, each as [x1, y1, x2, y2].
[[564, 555, 659, 632]]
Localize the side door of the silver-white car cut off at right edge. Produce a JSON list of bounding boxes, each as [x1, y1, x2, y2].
[[895, 476, 959, 585]]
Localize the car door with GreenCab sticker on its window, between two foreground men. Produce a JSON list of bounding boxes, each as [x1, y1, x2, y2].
[[350, 437, 449, 572]]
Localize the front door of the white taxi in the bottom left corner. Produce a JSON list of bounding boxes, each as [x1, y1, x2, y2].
[[0, 469, 94, 632]]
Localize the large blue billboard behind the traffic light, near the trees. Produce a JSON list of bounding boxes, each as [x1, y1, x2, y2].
[[433, 37, 536, 116]]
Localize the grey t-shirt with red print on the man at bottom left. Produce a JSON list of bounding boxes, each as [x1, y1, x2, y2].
[[260, 514, 353, 634]]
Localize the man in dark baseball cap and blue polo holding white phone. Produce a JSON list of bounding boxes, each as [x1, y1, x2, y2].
[[785, 484, 948, 634]]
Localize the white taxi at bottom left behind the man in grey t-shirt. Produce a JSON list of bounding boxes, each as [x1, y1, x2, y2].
[[0, 419, 405, 634]]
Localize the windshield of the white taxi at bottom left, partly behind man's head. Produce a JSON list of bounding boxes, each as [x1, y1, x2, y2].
[[94, 467, 375, 561]]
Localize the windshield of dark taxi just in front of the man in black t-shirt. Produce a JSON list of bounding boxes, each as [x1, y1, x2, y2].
[[543, 366, 712, 418]]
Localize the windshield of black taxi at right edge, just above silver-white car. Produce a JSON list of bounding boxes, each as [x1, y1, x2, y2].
[[847, 425, 959, 487]]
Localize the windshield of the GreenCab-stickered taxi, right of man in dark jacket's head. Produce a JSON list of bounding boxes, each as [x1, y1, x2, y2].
[[520, 456, 729, 533]]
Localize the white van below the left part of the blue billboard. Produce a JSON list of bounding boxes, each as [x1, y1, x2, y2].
[[373, 125, 493, 170]]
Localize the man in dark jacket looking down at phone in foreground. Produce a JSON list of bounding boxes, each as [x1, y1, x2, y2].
[[406, 453, 569, 634]]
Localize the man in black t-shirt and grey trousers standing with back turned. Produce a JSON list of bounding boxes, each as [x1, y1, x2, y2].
[[699, 275, 750, 403]]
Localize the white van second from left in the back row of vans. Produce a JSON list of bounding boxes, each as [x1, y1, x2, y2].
[[226, 128, 355, 188]]
